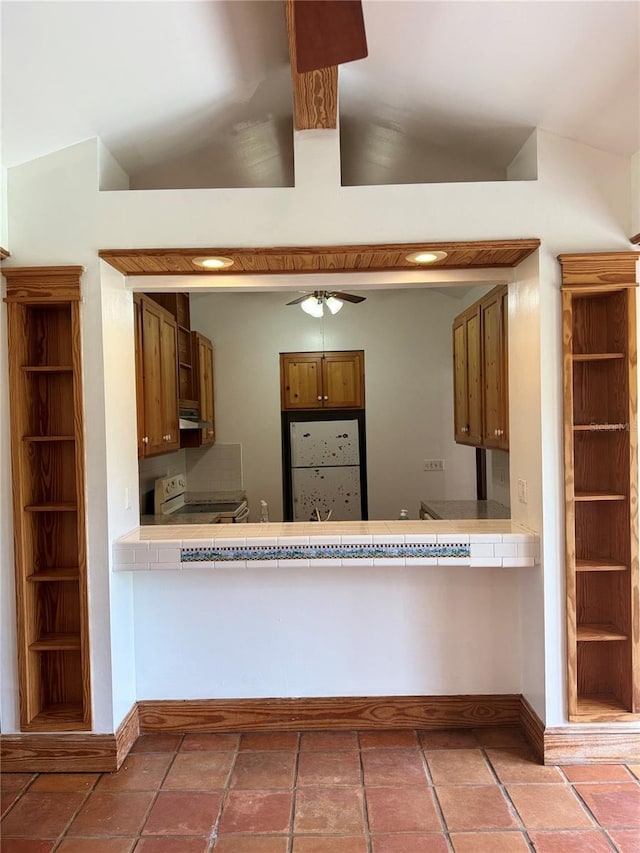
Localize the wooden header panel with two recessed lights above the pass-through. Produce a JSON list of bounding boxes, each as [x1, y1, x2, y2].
[[98, 239, 540, 276]]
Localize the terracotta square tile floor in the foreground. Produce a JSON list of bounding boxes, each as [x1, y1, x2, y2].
[[0, 729, 640, 853]]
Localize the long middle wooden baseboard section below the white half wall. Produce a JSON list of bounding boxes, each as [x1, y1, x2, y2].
[[138, 695, 520, 732]]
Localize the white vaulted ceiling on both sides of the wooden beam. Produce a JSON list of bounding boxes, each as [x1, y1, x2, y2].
[[0, 0, 640, 188]]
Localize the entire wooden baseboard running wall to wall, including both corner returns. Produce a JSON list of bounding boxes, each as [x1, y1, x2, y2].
[[0, 694, 640, 773]]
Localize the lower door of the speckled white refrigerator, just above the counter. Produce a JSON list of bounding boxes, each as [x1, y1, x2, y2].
[[292, 465, 362, 521]]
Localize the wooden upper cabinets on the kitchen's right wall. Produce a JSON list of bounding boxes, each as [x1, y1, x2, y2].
[[453, 286, 509, 450]]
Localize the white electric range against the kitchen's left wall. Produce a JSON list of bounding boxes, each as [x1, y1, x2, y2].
[[154, 474, 249, 524]]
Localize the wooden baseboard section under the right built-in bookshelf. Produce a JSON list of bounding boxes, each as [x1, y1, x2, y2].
[[544, 723, 640, 764]]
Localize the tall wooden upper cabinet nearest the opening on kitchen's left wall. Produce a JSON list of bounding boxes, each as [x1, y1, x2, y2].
[[135, 294, 180, 456]]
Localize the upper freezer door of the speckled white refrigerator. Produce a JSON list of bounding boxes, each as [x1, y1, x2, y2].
[[290, 420, 360, 468]]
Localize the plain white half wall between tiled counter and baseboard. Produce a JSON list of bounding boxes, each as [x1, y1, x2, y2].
[[134, 566, 530, 699]]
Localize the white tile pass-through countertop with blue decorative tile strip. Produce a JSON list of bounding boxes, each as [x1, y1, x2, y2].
[[113, 520, 539, 572]]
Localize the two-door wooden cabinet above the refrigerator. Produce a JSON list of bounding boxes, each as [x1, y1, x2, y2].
[[280, 350, 364, 411]]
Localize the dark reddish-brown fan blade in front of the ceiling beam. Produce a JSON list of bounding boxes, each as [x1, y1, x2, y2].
[[293, 0, 368, 74]]
